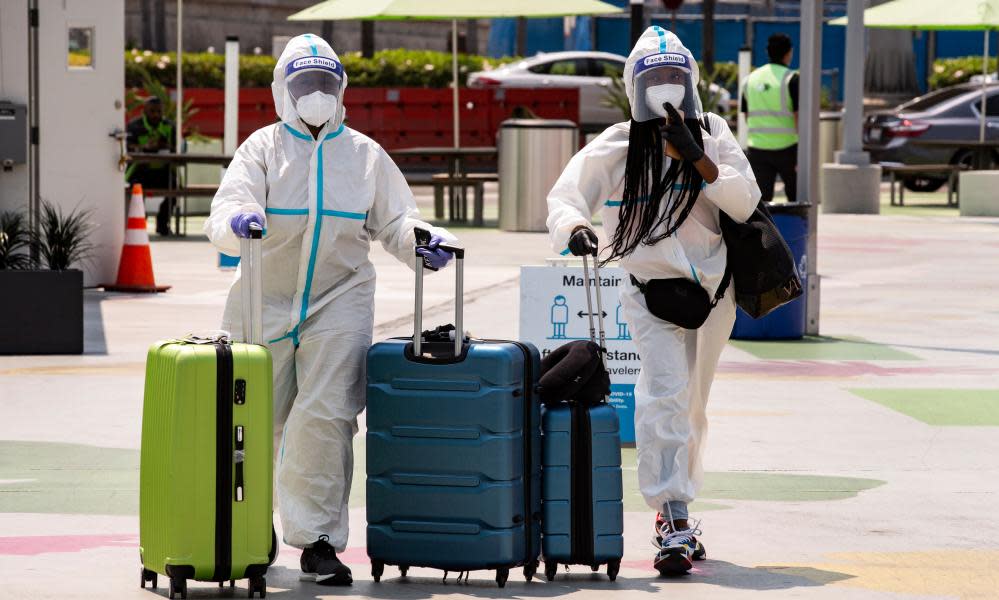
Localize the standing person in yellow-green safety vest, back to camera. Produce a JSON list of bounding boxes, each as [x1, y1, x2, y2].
[[742, 33, 798, 202]]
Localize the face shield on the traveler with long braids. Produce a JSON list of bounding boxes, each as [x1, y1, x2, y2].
[[631, 52, 702, 123]]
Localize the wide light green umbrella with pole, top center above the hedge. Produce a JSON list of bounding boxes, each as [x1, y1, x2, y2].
[[288, 0, 622, 148]]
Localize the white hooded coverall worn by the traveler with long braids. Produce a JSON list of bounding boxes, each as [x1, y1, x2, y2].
[[548, 27, 760, 518]]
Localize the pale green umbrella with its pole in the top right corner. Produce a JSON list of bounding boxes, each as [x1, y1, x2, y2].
[[829, 0, 999, 142]]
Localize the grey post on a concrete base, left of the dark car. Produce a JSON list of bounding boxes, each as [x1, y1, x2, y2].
[[822, 0, 881, 214]]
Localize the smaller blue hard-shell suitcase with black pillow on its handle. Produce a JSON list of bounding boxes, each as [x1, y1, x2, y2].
[[541, 257, 624, 581]]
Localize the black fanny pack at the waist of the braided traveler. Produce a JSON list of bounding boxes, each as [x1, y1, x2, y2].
[[631, 267, 732, 329]]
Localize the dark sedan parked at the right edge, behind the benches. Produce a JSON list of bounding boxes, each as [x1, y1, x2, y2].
[[864, 83, 999, 192]]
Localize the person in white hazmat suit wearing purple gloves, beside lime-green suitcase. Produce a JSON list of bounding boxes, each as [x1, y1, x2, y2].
[[205, 34, 454, 585]]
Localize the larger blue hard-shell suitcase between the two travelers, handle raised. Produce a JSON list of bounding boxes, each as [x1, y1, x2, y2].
[[367, 244, 541, 587]]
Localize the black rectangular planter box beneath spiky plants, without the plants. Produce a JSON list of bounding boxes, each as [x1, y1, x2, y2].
[[0, 270, 83, 354]]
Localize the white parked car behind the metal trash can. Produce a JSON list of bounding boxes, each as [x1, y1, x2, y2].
[[468, 51, 732, 130]]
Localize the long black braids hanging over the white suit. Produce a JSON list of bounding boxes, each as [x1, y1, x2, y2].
[[602, 118, 704, 264]]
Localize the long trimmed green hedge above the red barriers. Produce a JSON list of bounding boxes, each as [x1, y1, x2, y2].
[[125, 49, 517, 88]]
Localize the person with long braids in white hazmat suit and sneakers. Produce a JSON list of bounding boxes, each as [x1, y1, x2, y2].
[[548, 27, 760, 574]]
